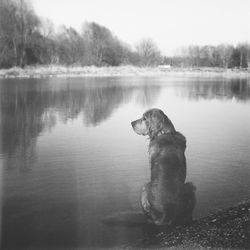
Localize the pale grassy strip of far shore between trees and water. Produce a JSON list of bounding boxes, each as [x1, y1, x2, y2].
[[0, 65, 250, 79]]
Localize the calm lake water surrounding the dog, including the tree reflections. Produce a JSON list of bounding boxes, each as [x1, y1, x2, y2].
[[0, 77, 250, 249]]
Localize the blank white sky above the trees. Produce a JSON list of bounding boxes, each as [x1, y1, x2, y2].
[[30, 0, 250, 55]]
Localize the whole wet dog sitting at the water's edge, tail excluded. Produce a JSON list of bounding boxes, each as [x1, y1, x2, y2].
[[131, 109, 195, 225]]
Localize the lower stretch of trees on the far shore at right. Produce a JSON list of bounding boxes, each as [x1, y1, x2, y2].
[[164, 43, 250, 69]]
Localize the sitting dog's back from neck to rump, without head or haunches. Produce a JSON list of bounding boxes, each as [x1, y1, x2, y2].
[[148, 132, 186, 224]]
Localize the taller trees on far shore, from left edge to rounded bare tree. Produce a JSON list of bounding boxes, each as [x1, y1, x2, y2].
[[0, 0, 162, 68]]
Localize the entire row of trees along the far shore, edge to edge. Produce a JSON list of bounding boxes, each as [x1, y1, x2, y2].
[[0, 0, 250, 68]]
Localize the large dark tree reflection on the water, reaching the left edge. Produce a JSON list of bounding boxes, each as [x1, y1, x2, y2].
[[0, 80, 160, 160]]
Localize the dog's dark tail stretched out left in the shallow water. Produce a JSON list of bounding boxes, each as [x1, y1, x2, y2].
[[102, 211, 147, 227]]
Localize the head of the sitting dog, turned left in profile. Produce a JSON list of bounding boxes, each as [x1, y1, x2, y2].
[[131, 109, 175, 140]]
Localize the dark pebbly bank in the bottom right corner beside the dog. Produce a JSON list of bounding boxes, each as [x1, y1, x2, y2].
[[125, 201, 250, 249]]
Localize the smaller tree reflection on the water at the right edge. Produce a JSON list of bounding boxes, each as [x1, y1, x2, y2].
[[176, 79, 250, 101]]
